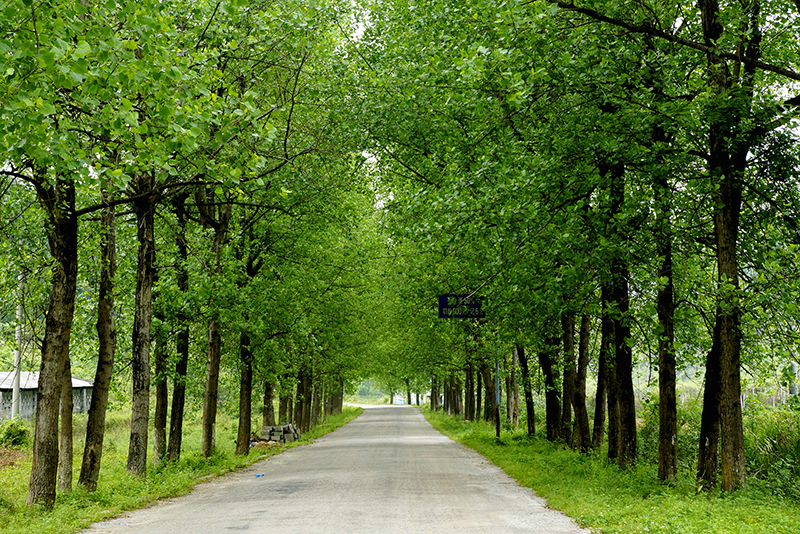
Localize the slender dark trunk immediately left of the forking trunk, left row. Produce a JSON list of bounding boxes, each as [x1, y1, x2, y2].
[[167, 195, 189, 461]]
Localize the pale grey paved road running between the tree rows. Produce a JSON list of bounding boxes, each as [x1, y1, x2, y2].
[[84, 406, 588, 534]]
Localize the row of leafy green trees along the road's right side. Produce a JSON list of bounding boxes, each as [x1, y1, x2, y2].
[[351, 0, 800, 498]]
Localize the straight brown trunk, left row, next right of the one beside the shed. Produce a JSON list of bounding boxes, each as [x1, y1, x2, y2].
[[128, 177, 156, 477]]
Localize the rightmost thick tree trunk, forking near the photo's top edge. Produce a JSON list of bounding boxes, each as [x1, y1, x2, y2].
[[698, 0, 761, 491]]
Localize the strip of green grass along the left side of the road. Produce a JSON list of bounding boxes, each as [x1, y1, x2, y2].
[[0, 406, 363, 534]]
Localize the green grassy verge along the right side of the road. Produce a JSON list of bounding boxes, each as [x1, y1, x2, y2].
[[425, 411, 800, 534]]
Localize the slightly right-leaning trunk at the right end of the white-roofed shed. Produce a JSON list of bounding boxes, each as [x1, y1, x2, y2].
[[78, 202, 117, 492]]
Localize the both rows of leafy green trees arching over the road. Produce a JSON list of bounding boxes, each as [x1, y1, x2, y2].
[[0, 0, 800, 505]]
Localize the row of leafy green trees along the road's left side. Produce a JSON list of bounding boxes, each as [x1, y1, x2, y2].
[[0, 0, 380, 505]]
